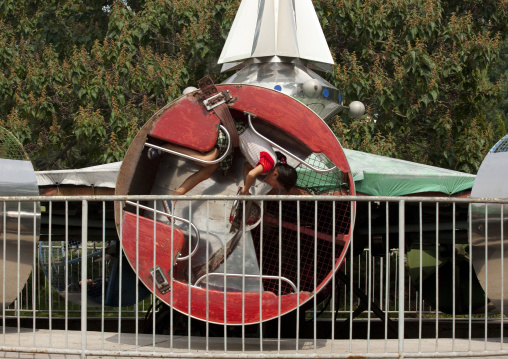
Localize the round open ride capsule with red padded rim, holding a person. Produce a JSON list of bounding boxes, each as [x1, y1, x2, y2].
[[116, 85, 354, 325]]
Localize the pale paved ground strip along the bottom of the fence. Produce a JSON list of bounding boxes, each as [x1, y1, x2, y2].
[[0, 327, 508, 359]]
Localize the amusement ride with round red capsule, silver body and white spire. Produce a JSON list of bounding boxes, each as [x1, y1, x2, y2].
[[0, 0, 508, 332]]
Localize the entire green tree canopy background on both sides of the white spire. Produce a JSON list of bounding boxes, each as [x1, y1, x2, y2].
[[0, 0, 508, 172]]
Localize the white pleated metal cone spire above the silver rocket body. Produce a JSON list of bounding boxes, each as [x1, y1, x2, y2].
[[218, 0, 333, 64]]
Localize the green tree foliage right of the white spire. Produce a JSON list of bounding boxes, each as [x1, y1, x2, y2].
[[315, 0, 508, 172]]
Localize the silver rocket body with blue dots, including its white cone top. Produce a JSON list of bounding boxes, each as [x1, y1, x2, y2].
[[218, 0, 344, 123]]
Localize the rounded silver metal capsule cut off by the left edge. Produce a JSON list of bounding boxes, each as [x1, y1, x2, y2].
[[0, 159, 41, 305]]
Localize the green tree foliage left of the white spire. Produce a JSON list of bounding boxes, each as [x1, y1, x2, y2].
[[0, 0, 239, 169]]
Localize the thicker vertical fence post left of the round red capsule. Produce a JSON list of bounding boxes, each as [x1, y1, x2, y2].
[[81, 200, 88, 358]]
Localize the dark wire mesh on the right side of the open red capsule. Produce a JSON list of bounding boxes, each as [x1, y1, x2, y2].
[[253, 153, 351, 295]]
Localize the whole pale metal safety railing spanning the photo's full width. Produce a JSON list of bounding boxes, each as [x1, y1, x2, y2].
[[0, 196, 508, 358]]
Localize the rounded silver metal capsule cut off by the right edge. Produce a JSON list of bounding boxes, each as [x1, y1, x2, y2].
[[471, 151, 508, 313]]
